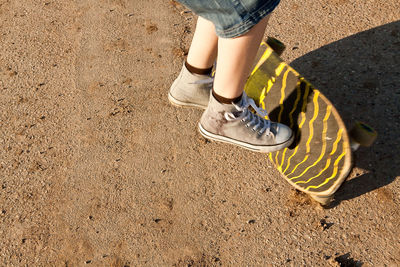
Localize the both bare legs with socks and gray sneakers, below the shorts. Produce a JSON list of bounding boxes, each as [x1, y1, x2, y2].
[[172, 13, 293, 152]]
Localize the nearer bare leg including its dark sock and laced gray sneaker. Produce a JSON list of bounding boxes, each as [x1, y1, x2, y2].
[[199, 14, 294, 152]]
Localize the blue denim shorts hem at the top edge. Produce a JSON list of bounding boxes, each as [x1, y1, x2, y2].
[[178, 0, 280, 38]]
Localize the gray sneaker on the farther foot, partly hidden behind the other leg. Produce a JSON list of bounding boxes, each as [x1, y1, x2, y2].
[[168, 64, 214, 109]]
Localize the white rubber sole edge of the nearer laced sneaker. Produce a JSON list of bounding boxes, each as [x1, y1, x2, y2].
[[199, 123, 294, 153]]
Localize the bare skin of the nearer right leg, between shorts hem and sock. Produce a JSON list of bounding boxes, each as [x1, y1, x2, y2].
[[214, 16, 269, 99]]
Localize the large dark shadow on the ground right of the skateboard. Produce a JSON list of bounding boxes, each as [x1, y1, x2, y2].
[[290, 21, 400, 206]]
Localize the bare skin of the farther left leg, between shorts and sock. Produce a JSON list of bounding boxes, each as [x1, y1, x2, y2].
[[187, 17, 218, 69]]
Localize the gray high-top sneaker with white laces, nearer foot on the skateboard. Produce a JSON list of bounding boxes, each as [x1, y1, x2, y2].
[[199, 92, 294, 152]]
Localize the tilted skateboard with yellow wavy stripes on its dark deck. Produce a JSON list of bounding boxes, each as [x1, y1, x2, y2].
[[245, 38, 377, 205]]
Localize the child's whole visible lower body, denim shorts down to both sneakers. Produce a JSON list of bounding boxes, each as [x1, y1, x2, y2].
[[168, 0, 293, 152]]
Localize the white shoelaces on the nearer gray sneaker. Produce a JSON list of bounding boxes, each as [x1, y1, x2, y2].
[[225, 92, 271, 135]]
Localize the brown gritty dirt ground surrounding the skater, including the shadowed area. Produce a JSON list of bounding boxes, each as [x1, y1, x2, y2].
[[0, 0, 400, 266]]
